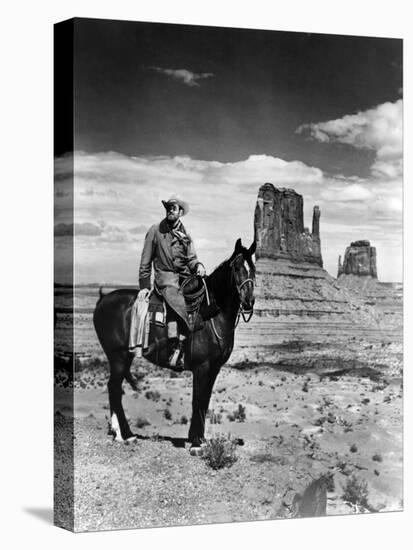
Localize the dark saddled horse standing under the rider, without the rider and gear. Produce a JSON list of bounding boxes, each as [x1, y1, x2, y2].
[[93, 239, 255, 448]]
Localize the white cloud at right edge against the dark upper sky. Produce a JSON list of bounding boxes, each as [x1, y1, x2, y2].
[[296, 99, 403, 179]]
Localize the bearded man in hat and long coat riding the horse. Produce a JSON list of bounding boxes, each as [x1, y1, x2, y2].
[[139, 195, 206, 370]]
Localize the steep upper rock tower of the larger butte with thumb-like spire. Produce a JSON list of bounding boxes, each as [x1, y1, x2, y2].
[[254, 183, 323, 267]]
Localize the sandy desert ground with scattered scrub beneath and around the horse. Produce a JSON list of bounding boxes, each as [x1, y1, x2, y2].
[[55, 289, 403, 531]]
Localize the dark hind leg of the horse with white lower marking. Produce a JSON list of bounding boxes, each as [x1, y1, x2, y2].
[[108, 351, 135, 441]]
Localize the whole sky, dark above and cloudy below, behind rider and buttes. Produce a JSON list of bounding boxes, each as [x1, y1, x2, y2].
[[55, 19, 403, 285]]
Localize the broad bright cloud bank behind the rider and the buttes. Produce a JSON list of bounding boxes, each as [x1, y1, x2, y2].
[[55, 144, 402, 284]]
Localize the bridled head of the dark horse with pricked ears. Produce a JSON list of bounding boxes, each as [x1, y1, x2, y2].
[[230, 239, 256, 320]]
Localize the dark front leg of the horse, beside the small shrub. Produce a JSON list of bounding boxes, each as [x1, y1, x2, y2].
[[188, 361, 219, 448]]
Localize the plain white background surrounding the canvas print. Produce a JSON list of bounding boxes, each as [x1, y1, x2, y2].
[[1, 0, 412, 549]]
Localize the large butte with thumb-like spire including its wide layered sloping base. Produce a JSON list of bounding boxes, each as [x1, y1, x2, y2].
[[229, 183, 402, 368]]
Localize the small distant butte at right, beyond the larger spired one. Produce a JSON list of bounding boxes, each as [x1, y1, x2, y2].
[[337, 241, 377, 279]]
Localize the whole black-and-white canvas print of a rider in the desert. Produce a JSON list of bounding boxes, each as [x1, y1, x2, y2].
[[54, 18, 403, 532]]
